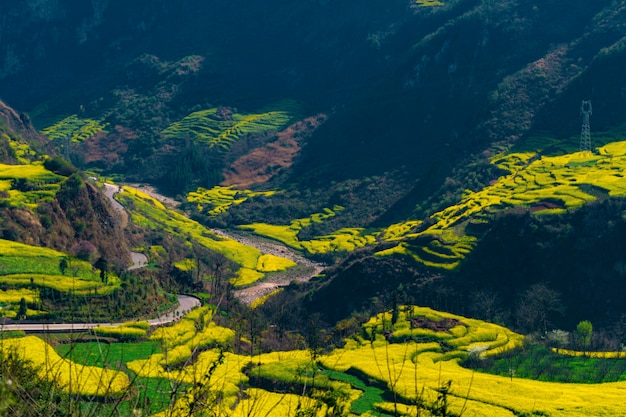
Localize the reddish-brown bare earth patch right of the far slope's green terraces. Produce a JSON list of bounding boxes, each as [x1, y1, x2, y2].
[[221, 114, 327, 188]]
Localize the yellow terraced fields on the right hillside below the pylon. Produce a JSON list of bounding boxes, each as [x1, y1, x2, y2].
[[377, 141, 626, 270]]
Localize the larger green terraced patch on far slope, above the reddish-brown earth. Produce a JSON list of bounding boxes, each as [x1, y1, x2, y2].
[[162, 101, 298, 150]]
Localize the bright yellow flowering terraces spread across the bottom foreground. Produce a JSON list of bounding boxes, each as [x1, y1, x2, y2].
[[7, 306, 626, 417]]
